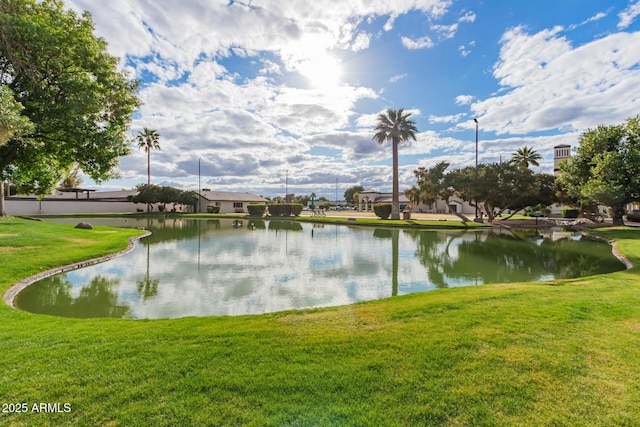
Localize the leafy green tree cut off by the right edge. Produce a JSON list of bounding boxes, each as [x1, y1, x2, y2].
[[558, 115, 640, 225]]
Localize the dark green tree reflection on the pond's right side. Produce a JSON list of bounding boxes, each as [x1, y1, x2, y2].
[[405, 230, 621, 288]]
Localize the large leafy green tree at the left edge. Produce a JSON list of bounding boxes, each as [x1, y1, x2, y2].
[[0, 0, 140, 214]]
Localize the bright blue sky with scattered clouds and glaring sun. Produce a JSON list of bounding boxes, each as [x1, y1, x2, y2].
[[65, 0, 640, 199]]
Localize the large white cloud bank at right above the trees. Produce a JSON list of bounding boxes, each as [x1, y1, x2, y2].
[[472, 27, 640, 134]]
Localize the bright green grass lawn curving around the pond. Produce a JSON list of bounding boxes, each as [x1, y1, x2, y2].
[[0, 219, 640, 426]]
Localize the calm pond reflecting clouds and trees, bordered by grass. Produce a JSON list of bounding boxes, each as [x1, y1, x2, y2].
[[14, 218, 624, 319]]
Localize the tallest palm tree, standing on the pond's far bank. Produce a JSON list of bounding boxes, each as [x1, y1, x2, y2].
[[373, 108, 418, 219]]
